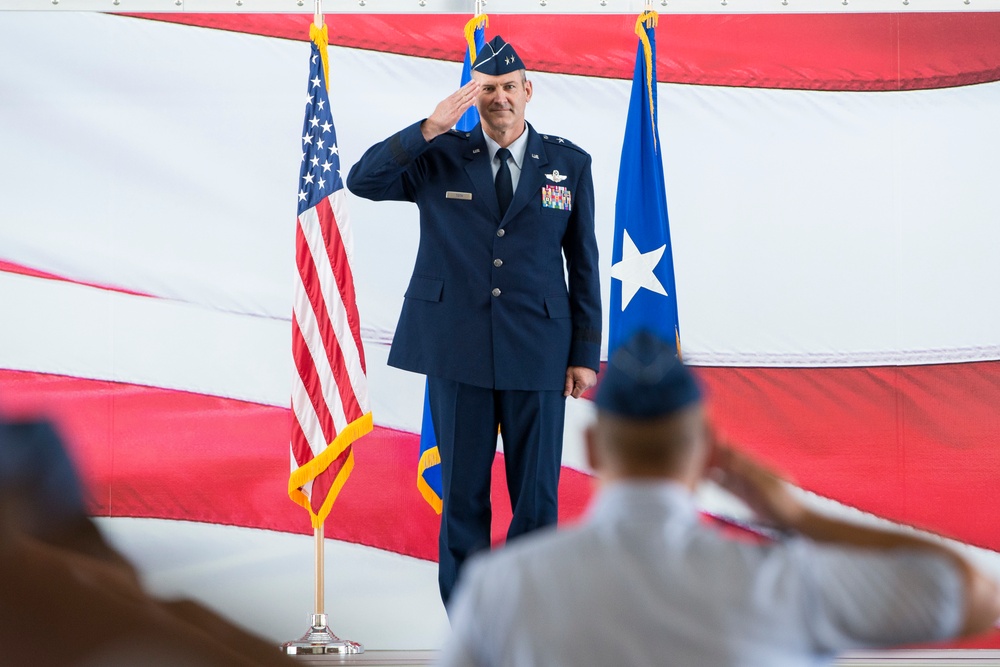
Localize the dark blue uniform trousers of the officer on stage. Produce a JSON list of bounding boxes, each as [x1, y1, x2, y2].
[[427, 377, 566, 606]]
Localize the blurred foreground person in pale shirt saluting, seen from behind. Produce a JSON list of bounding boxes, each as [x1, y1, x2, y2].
[[442, 333, 1000, 667]]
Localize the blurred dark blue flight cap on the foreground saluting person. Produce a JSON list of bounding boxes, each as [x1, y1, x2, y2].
[[594, 331, 702, 419]]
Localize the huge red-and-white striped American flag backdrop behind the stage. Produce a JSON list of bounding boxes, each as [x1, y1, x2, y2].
[[0, 12, 1000, 648]]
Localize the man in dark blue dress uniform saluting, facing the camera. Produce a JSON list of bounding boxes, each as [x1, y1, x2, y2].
[[347, 36, 601, 604]]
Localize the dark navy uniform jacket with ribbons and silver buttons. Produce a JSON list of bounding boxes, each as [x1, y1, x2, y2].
[[347, 122, 601, 390]]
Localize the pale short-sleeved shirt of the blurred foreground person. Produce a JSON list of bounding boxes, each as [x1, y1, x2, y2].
[[441, 483, 963, 667]]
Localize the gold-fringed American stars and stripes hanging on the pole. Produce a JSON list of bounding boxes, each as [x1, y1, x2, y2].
[[288, 25, 372, 528]]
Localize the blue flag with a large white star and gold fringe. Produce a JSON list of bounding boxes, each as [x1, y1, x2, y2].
[[608, 12, 680, 356]]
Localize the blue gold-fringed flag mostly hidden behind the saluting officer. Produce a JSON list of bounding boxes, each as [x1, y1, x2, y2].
[[417, 14, 489, 514]]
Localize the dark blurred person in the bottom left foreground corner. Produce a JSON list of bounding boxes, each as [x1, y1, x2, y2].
[[0, 422, 294, 667]]
